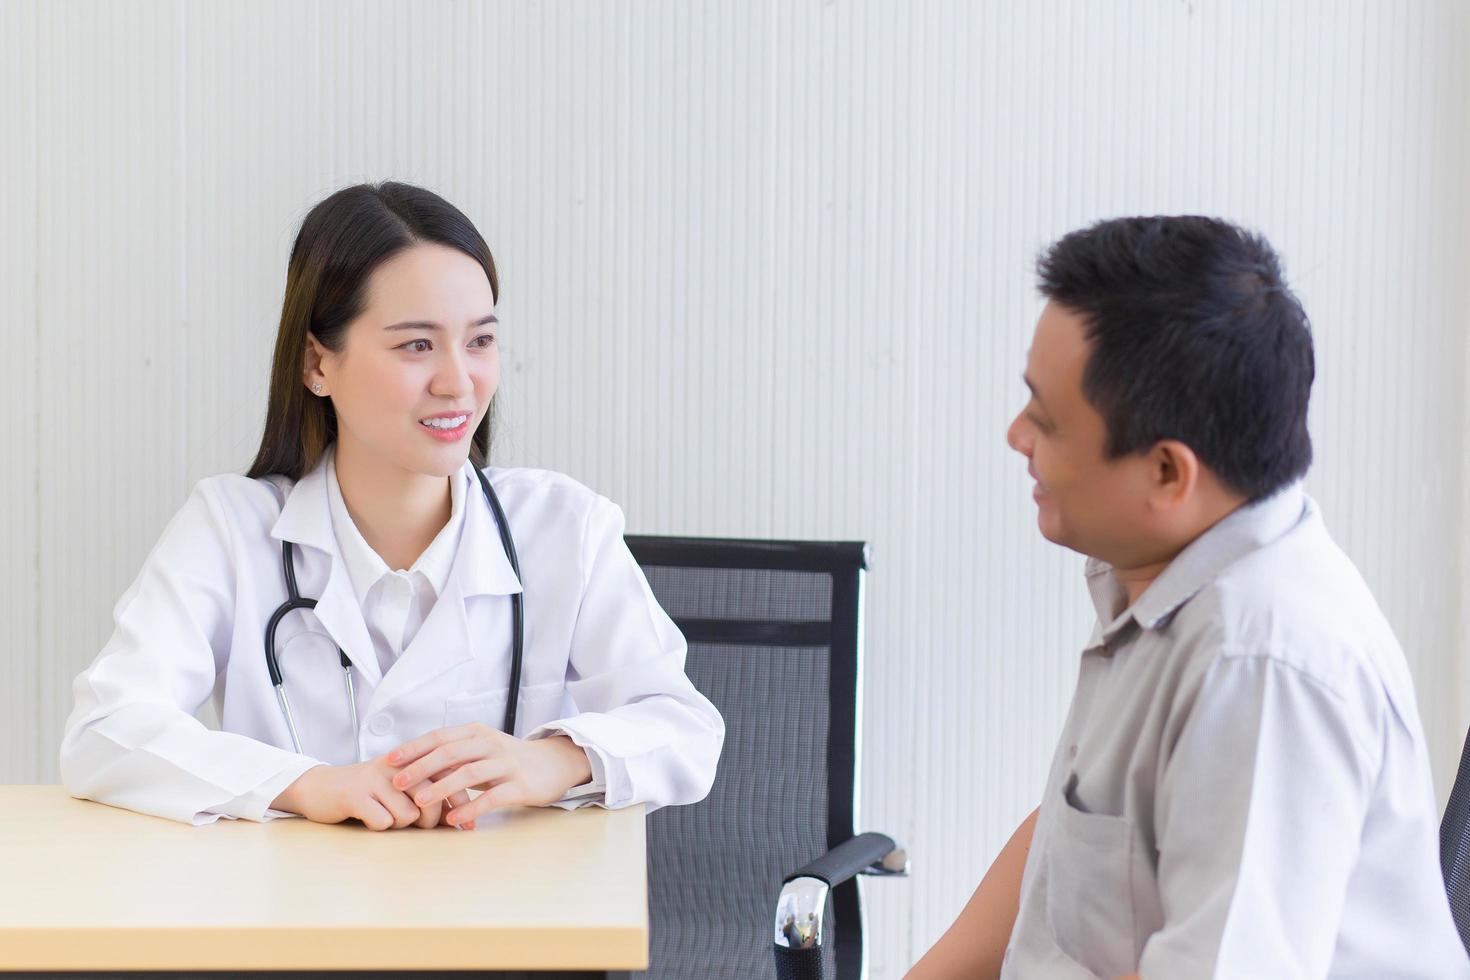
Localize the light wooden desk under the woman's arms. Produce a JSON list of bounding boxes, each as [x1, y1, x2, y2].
[[0, 786, 648, 971]]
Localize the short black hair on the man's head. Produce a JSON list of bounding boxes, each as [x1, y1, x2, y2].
[[1036, 216, 1316, 500]]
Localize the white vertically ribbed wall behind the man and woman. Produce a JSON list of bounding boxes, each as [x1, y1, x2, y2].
[[0, 0, 1470, 977]]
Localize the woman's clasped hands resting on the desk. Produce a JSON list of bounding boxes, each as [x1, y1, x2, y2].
[[272, 723, 592, 830]]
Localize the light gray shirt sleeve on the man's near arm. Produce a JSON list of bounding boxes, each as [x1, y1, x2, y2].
[[1139, 652, 1383, 980]]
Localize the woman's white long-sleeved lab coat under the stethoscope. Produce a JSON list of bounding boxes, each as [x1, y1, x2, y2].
[[62, 461, 725, 823]]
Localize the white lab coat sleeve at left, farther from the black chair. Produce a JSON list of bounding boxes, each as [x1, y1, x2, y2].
[[60, 486, 319, 824]]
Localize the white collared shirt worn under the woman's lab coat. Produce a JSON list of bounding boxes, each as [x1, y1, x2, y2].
[[326, 447, 469, 673]]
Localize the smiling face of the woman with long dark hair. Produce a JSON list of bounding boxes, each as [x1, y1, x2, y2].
[[304, 244, 500, 476]]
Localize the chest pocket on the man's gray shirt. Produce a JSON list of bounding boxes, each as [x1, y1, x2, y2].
[[1047, 774, 1138, 977]]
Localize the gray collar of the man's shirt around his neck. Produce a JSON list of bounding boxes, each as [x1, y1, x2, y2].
[[1086, 483, 1317, 649]]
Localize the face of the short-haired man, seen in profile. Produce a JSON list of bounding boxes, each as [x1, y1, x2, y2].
[[1005, 303, 1157, 567]]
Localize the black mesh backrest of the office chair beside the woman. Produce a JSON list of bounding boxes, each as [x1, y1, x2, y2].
[[613, 536, 866, 980]]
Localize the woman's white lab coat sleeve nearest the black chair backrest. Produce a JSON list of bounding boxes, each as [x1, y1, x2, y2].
[[526, 498, 725, 810]]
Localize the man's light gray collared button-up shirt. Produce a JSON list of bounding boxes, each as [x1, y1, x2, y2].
[[1001, 486, 1470, 980]]
